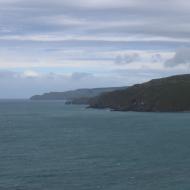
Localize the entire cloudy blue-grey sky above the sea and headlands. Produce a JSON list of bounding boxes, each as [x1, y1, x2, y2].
[[0, 0, 190, 98]]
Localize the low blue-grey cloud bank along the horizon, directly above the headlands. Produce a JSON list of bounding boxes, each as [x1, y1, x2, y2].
[[0, 66, 189, 98]]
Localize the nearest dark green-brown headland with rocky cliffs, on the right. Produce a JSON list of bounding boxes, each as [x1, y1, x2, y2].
[[90, 75, 190, 112]]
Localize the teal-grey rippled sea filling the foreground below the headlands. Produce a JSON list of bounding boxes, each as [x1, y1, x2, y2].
[[0, 101, 190, 190]]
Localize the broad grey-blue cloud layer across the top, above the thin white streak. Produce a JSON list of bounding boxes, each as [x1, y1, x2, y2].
[[0, 0, 190, 43]]
